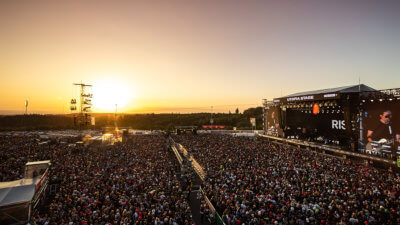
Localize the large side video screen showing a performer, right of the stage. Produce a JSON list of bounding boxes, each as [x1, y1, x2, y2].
[[359, 100, 400, 158]]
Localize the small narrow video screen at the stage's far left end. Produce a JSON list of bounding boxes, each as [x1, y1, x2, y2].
[[265, 106, 283, 137]]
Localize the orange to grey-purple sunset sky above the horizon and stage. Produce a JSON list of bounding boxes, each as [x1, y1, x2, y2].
[[0, 0, 400, 114]]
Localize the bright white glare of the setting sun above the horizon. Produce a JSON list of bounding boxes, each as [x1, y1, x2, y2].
[[93, 80, 134, 112]]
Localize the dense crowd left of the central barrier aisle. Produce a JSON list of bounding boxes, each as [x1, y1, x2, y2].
[[0, 136, 193, 225]]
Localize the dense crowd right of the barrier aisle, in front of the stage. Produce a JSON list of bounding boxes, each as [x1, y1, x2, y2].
[[174, 135, 400, 225]]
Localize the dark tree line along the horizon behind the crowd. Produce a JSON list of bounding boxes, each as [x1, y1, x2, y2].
[[0, 107, 262, 131]]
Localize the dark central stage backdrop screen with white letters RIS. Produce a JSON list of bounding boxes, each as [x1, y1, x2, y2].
[[284, 108, 347, 145]]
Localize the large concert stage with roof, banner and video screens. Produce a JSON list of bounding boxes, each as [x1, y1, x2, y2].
[[263, 84, 400, 159]]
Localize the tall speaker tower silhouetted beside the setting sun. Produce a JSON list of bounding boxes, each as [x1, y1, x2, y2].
[[70, 83, 94, 129]]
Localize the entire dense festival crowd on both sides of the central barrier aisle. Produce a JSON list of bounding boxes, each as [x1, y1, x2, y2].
[[0, 132, 400, 225]]
